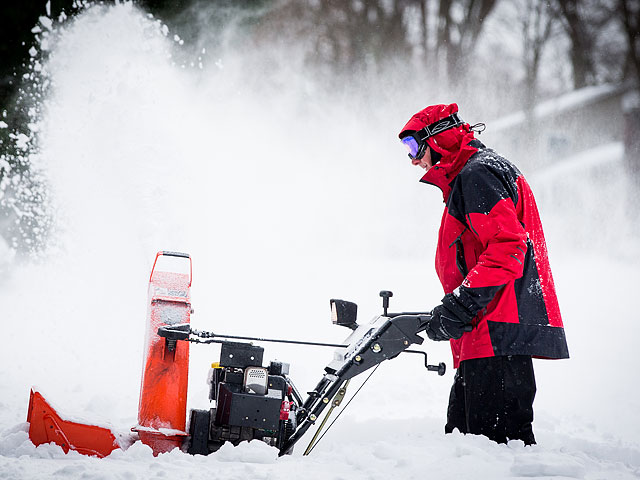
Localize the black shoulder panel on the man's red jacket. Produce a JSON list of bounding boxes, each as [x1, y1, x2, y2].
[[447, 148, 521, 225]]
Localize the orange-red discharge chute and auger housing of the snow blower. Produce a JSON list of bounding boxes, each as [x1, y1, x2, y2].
[[27, 251, 192, 457]]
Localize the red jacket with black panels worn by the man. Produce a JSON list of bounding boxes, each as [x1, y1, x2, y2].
[[405, 104, 569, 368]]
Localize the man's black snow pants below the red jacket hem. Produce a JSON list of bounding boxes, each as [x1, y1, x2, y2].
[[444, 355, 536, 445]]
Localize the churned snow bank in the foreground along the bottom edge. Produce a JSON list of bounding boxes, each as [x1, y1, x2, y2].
[[0, 419, 640, 480]]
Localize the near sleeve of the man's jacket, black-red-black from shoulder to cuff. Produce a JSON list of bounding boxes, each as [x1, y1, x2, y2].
[[454, 163, 527, 315]]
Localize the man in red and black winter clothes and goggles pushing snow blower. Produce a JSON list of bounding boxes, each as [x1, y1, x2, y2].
[[399, 103, 569, 445]]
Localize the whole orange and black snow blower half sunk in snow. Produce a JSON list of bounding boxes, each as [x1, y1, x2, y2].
[[27, 252, 445, 457]]
